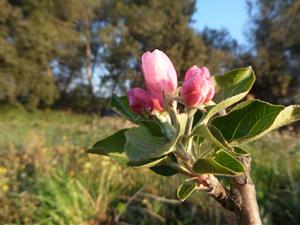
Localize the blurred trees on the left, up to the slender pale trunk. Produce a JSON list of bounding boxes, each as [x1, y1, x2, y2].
[[0, 0, 105, 107]]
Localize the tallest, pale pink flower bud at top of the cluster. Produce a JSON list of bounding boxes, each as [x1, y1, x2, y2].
[[141, 49, 177, 98]]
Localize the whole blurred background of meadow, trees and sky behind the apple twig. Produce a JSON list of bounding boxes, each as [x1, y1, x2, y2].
[[0, 0, 300, 225]]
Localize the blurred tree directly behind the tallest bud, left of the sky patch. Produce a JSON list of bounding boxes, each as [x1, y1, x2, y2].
[[102, 0, 238, 95]]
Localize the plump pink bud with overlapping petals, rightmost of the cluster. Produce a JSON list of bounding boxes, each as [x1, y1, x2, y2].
[[181, 66, 215, 107]]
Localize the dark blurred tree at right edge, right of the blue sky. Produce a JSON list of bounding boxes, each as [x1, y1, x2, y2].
[[248, 0, 300, 104]]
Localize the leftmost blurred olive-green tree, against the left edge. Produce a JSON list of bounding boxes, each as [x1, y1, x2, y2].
[[0, 0, 72, 107]]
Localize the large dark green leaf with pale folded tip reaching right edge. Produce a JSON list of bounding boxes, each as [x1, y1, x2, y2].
[[211, 100, 300, 145]]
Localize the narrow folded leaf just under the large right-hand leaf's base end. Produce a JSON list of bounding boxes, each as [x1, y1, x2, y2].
[[192, 124, 233, 150]]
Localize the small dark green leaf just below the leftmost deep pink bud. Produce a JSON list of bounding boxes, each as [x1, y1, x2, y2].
[[110, 94, 141, 123]]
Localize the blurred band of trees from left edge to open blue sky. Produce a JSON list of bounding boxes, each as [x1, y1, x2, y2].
[[0, 0, 239, 111]]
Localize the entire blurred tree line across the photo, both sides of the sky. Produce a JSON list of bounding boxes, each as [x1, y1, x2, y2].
[[0, 0, 300, 111]]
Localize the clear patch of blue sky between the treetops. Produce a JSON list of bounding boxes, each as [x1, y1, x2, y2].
[[193, 0, 248, 44]]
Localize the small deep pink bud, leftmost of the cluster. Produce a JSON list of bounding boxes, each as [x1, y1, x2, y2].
[[127, 88, 150, 114]]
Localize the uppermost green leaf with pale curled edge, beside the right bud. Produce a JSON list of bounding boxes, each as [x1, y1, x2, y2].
[[203, 67, 255, 123]]
